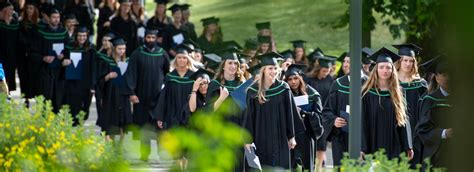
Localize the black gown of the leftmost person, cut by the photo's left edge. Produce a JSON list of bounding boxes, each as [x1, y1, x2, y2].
[[0, 20, 20, 91]]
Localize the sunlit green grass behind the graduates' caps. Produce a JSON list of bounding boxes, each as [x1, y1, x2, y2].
[[143, 0, 404, 55]]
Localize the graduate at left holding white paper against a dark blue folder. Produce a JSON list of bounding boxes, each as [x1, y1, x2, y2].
[[62, 26, 96, 125]]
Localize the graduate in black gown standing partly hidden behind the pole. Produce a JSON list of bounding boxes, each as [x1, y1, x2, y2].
[[322, 50, 367, 166]]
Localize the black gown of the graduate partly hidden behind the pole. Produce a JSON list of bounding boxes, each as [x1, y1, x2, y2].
[[322, 75, 367, 165]]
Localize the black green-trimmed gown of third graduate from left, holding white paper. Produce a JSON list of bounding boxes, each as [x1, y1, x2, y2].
[[38, 26, 67, 112]]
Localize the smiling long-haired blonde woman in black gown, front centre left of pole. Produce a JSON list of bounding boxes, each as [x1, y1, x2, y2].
[[244, 53, 304, 169]]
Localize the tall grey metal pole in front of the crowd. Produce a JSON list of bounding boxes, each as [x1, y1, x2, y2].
[[349, 0, 363, 158]]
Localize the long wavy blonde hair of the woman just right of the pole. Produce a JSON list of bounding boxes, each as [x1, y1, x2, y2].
[[362, 64, 408, 126]]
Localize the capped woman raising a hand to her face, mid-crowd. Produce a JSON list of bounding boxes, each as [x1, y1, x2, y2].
[[182, 68, 213, 126]]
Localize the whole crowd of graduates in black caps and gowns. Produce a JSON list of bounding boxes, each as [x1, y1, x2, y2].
[[0, 0, 453, 170]]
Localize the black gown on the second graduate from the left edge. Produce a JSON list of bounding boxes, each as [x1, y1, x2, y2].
[[17, 22, 40, 98]]
